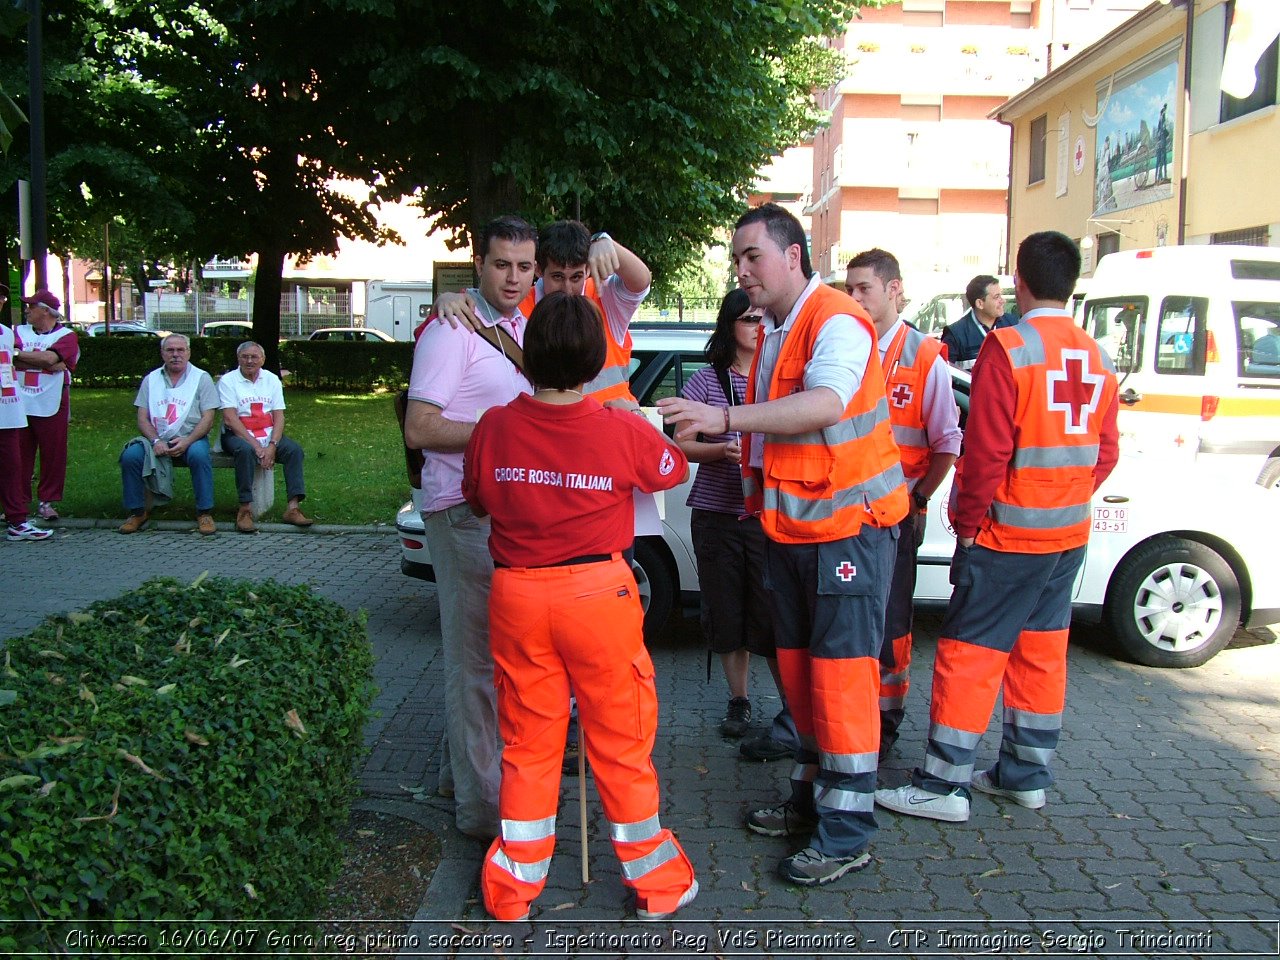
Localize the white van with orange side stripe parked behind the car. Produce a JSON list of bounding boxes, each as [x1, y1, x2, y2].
[[1082, 246, 1280, 477]]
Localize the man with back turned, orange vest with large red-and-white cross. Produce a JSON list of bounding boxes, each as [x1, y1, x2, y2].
[[876, 230, 1119, 822]]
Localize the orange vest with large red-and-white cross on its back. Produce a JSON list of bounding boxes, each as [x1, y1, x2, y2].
[[977, 314, 1116, 553]]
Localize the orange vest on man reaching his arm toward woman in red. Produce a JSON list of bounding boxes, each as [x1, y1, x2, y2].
[[742, 284, 908, 543]]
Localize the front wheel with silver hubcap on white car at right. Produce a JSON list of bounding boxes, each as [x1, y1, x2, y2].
[[1103, 536, 1240, 668]]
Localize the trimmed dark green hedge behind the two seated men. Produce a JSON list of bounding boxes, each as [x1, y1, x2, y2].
[[73, 337, 413, 393]]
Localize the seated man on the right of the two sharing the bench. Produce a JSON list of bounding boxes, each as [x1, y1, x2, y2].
[[218, 340, 314, 534]]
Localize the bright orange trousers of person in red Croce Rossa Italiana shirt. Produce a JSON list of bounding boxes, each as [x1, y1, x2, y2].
[[480, 554, 694, 920]]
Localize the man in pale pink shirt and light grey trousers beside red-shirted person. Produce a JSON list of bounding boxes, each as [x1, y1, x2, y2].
[[404, 216, 538, 840]]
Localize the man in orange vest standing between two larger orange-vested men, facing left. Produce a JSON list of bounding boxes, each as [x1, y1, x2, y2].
[[845, 247, 961, 760]]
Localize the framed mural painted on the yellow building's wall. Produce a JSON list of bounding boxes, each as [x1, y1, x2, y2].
[[1093, 50, 1178, 216]]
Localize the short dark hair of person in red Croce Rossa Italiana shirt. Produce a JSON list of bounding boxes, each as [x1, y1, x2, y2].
[[525, 292, 604, 390]]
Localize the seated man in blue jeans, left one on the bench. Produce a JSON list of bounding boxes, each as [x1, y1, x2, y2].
[[120, 333, 218, 536]]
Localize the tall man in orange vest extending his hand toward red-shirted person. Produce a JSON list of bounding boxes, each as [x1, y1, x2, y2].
[[658, 204, 908, 886]]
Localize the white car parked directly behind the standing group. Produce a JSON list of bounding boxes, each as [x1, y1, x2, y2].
[[396, 325, 1280, 667]]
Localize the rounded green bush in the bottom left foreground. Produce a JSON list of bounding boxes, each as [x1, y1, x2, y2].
[[0, 577, 374, 952]]
